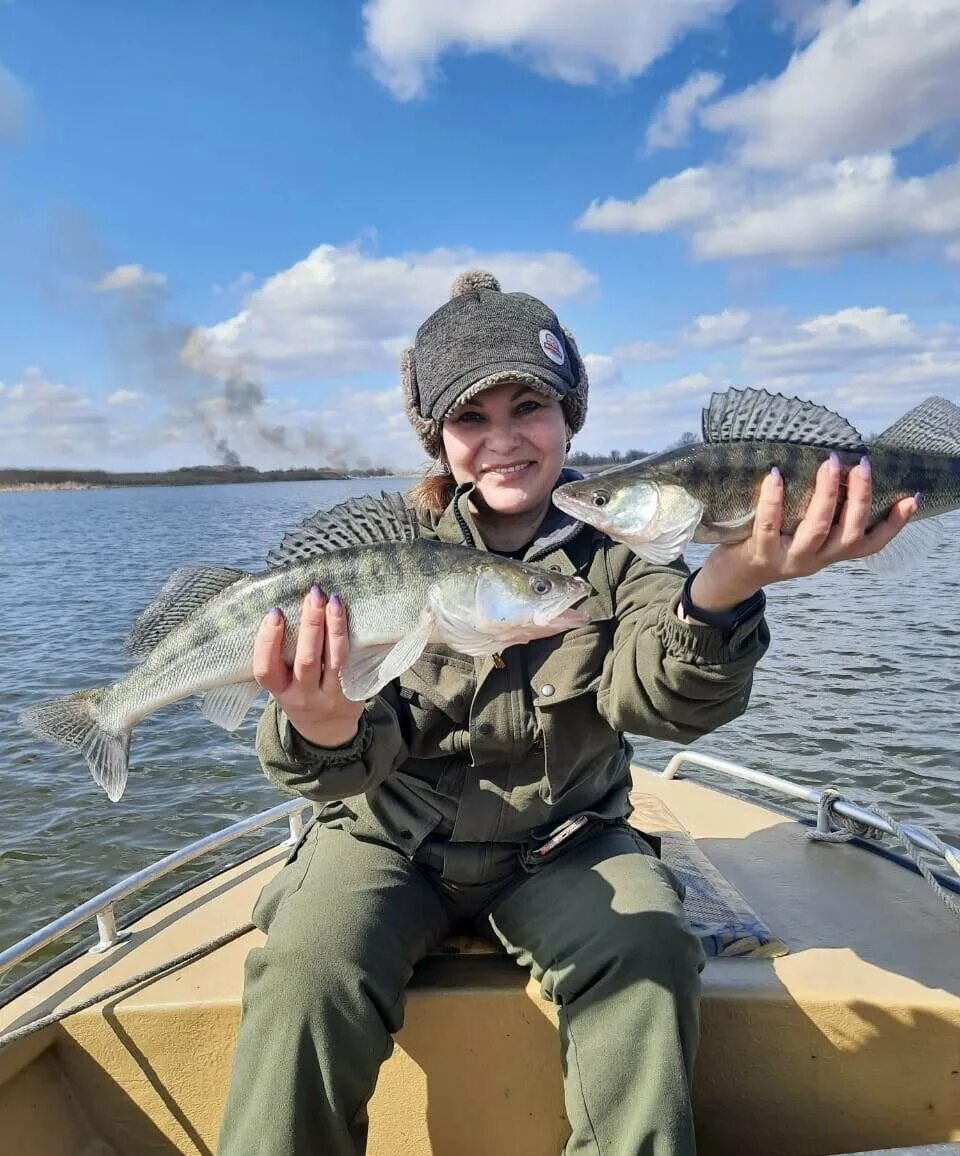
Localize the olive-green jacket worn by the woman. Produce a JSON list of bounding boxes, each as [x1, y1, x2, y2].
[[257, 473, 769, 855]]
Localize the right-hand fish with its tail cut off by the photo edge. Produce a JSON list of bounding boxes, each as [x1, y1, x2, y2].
[[553, 388, 960, 571]]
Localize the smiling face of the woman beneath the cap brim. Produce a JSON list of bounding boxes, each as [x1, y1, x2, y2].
[[443, 381, 567, 514]]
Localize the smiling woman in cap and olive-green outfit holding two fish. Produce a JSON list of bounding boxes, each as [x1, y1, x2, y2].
[[220, 273, 911, 1156]]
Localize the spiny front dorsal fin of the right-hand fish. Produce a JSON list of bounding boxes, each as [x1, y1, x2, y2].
[[702, 390, 863, 451]]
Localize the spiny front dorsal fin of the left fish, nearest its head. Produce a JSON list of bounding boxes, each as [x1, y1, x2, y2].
[[267, 492, 420, 566]]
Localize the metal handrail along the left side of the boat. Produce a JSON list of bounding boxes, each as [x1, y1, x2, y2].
[[0, 799, 309, 976]]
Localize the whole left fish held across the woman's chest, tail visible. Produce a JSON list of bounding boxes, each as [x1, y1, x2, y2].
[[20, 494, 592, 802]]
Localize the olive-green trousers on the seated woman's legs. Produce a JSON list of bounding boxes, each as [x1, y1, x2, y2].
[[219, 823, 703, 1156]]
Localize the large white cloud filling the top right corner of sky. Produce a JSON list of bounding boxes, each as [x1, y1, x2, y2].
[[701, 0, 960, 169]]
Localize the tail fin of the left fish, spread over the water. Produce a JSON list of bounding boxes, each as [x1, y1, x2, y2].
[[20, 687, 131, 802]]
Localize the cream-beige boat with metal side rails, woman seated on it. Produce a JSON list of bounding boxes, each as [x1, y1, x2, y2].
[[0, 750, 960, 1156]]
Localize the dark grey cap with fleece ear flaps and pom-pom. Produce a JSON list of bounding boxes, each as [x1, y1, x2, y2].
[[400, 269, 588, 458]]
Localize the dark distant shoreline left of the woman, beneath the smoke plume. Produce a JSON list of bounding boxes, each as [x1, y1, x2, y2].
[[0, 466, 405, 494]]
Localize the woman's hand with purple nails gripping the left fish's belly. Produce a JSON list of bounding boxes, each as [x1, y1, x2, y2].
[[253, 586, 363, 747]]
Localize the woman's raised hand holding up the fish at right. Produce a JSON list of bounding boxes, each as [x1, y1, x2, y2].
[[691, 454, 917, 613]]
